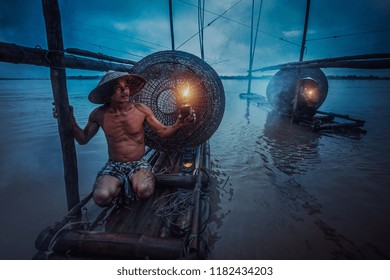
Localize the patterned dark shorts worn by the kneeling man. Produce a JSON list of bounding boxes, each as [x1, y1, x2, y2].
[[97, 158, 152, 197]]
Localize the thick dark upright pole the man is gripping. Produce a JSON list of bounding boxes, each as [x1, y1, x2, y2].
[[42, 0, 80, 210]]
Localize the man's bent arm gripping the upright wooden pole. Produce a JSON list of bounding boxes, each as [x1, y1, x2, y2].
[[69, 106, 99, 145]]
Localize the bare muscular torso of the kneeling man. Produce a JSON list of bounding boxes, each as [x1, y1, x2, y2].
[[91, 103, 146, 162]]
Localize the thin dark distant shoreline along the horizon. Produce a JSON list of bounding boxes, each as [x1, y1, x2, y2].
[[0, 75, 390, 80]]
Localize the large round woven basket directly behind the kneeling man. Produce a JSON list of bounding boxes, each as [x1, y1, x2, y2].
[[131, 51, 225, 150]]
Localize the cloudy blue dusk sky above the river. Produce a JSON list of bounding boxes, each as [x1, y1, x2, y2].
[[0, 0, 390, 78]]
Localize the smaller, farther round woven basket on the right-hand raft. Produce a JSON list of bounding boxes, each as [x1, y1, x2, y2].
[[266, 68, 328, 115]]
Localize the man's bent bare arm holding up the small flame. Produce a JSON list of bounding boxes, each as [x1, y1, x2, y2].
[[137, 104, 194, 137]]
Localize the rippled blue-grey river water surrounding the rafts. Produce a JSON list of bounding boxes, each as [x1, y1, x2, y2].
[[0, 77, 390, 259]]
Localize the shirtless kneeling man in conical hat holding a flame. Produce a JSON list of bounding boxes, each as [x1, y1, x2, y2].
[[66, 71, 196, 206]]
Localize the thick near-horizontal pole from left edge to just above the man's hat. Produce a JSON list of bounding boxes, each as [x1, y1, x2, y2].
[[0, 42, 132, 72]]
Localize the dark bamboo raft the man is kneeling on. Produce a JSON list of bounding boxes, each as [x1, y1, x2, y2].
[[34, 141, 210, 259]]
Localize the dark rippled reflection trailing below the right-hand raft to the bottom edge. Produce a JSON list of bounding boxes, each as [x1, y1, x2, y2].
[[256, 111, 364, 259]]
